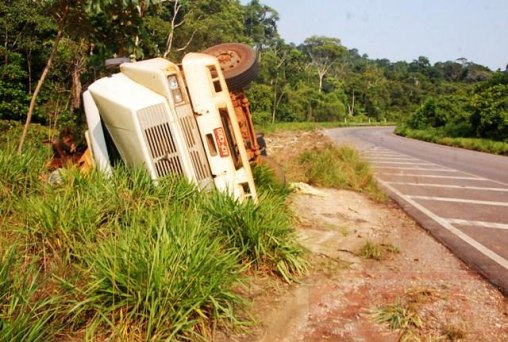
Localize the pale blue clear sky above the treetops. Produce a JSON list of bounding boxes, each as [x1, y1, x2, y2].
[[241, 0, 508, 70]]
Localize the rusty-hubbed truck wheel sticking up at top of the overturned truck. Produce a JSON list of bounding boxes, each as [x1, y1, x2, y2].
[[203, 43, 258, 91]]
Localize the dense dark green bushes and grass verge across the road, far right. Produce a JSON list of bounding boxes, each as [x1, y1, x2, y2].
[[396, 72, 508, 155]]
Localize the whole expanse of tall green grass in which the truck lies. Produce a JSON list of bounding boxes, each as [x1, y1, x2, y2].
[[0, 125, 307, 341]]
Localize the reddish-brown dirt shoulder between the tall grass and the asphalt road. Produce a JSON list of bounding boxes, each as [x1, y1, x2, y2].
[[234, 132, 508, 341]]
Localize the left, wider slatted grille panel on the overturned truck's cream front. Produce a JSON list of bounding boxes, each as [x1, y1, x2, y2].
[[137, 104, 183, 177]]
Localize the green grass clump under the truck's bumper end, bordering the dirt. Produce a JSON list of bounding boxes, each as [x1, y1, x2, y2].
[[206, 193, 306, 281]]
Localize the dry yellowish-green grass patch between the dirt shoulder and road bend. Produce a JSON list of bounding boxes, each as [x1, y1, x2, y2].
[[299, 144, 386, 202]]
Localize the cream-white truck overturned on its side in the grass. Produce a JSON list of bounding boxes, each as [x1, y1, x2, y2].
[[83, 43, 264, 201]]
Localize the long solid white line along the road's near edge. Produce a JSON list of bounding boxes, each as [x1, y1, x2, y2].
[[378, 179, 508, 270]]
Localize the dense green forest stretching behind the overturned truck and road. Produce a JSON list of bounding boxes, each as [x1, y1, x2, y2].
[[0, 0, 508, 141]]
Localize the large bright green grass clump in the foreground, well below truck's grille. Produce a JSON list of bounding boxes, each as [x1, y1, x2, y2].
[[64, 205, 241, 340]]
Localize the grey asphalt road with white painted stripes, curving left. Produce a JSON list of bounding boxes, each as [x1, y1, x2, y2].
[[327, 127, 508, 294]]
